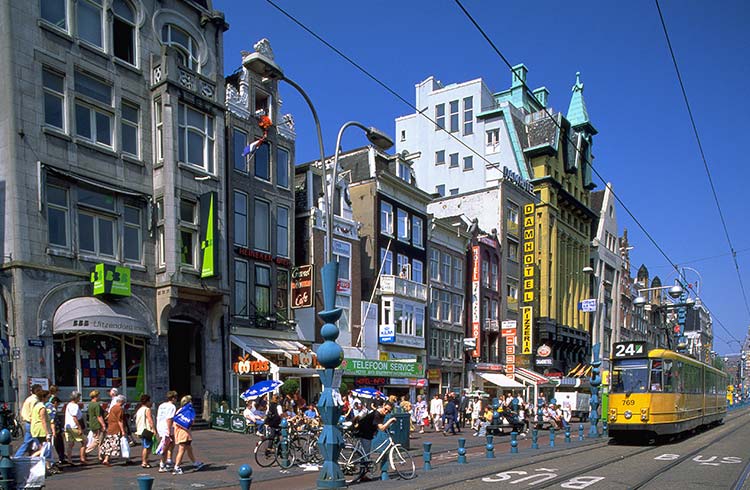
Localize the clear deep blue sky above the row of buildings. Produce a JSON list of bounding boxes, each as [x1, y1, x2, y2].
[[214, 0, 750, 354]]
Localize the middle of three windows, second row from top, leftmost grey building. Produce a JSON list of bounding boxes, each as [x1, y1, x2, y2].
[[75, 72, 112, 147]]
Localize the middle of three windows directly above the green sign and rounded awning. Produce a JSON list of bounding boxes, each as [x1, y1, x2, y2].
[[78, 188, 117, 258]]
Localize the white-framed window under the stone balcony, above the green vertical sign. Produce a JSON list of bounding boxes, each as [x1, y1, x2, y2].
[[177, 103, 214, 173]]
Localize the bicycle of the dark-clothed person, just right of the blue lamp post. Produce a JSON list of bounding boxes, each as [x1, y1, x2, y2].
[[339, 432, 416, 483]]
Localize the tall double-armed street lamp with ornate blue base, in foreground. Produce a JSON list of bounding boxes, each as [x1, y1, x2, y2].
[[242, 47, 393, 488]]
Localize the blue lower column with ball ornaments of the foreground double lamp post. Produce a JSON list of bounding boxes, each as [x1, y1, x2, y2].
[[317, 262, 346, 489]]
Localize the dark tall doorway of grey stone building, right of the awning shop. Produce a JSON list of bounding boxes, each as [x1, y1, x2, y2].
[[169, 319, 203, 404]]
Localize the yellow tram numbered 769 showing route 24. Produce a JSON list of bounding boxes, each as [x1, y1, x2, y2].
[[606, 342, 727, 439]]
